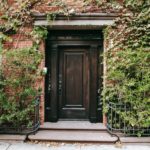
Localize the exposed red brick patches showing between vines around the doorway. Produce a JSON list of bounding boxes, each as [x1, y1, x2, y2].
[[0, 0, 123, 124]]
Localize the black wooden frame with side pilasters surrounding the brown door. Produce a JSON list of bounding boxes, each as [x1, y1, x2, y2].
[[45, 30, 103, 122]]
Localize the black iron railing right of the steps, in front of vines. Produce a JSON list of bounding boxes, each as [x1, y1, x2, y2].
[[107, 103, 150, 136]]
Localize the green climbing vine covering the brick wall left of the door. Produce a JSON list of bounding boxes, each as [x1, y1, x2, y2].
[[0, 0, 47, 130]]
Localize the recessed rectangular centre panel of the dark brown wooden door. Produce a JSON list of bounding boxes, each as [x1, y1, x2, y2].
[[63, 52, 84, 107]]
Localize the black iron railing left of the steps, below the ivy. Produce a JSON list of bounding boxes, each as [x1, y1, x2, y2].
[[0, 97, 40, 135]]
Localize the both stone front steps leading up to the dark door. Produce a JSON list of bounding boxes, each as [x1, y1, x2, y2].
[[28, 121, 117, 143]]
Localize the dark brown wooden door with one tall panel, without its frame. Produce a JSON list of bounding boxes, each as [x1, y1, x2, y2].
[[59, 46, 89, 119]]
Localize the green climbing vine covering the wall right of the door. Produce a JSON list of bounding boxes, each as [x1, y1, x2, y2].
[[103, 0, 150, 135]]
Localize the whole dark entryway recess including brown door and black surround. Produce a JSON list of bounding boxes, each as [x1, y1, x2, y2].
[[45, 30, 103, 122]]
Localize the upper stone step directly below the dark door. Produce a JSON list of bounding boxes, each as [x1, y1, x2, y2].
[[40, 121, 106, 131]]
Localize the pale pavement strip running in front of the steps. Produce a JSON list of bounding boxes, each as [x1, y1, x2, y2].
[[0, 141, 150, 150]]
